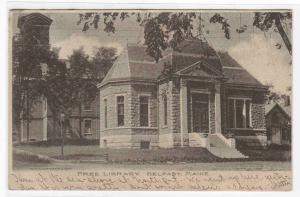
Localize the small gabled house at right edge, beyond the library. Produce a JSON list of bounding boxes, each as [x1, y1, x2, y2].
[[266, 97, 292, 145]]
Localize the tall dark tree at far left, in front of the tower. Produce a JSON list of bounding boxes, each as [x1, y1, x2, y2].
[[12, 32, 49, 141]]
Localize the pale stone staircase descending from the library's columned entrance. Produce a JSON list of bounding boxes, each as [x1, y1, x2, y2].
[[207, 135, 248, 159]]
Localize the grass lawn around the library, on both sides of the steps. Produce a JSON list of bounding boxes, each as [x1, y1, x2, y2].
[[15, 145, 291, 163]]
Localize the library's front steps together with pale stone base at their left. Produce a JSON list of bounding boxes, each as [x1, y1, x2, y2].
[[189, 133, 248, 159]]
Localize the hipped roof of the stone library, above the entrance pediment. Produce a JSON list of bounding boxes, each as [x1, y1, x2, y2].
[[100, 39, 265, 87]]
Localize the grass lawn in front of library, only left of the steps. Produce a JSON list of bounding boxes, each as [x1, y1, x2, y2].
[[15, 145, 218, 163]]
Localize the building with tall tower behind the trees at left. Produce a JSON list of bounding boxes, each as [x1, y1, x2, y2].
[[15, 13, 100, 142]]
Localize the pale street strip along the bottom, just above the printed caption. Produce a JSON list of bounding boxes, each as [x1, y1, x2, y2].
[[14, 161, 291, 171]]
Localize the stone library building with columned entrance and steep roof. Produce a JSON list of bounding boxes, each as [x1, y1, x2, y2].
[[98, 38, 268, 157]]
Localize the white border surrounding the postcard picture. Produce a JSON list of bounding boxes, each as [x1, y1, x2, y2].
[[0, 0, 300, 197]]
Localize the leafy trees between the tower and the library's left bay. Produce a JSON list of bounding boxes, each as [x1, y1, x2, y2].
[[39, 47, 116, 137]]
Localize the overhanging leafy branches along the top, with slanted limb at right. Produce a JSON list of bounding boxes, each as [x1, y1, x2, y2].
[[77, 12, 292, 61]]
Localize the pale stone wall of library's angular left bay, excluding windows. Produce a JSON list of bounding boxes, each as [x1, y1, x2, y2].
[[100, 83, 158, 149]]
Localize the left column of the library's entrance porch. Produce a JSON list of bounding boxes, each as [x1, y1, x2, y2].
[[180, 79, 188, 147]]
